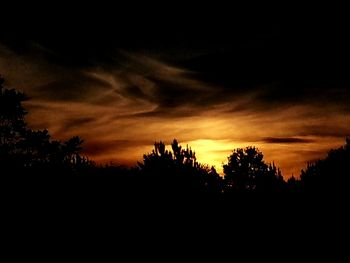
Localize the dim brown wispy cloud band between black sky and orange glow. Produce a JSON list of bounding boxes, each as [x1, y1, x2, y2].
[[0, 42, 350, 115]]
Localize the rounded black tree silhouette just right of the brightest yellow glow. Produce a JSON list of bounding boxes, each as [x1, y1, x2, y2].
[[223, 147, 284, 192]]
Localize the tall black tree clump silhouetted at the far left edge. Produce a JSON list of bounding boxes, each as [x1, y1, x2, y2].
[[0, 76, 92, 172]]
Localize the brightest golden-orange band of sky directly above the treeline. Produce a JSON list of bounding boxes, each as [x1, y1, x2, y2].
[[26, 98, 350, 177]]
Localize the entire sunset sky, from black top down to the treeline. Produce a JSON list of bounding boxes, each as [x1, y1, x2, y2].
[[0, 10, 350, 178]]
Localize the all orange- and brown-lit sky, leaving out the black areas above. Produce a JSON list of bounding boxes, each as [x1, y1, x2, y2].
[[0, 45, 350, 178]]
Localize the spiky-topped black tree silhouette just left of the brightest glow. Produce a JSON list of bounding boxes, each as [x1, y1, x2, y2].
[[138, 139, 221, 192]]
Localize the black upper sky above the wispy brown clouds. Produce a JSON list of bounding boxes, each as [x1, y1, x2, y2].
[[2, 7, 350, 92]]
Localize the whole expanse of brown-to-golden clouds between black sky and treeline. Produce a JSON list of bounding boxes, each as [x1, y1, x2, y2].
[[0, 40, 350, 179]]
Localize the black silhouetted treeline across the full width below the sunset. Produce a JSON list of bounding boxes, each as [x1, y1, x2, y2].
[[0, 78, 350, 196]]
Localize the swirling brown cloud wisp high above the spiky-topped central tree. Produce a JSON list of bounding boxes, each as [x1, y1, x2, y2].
[[112, 54, 224, 109]]
